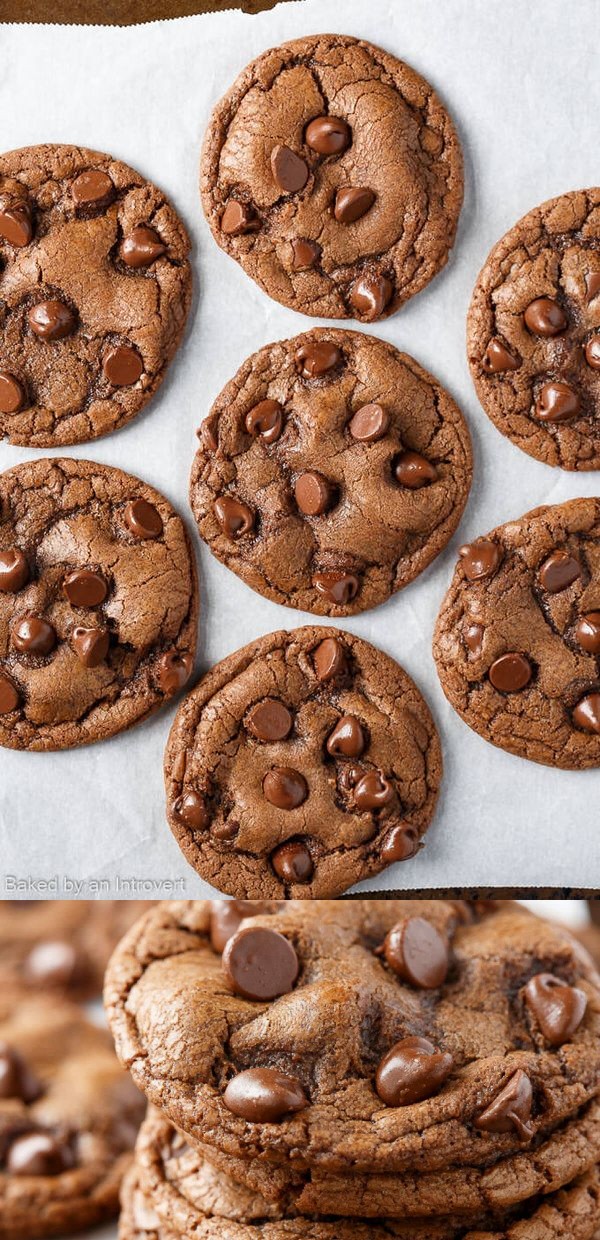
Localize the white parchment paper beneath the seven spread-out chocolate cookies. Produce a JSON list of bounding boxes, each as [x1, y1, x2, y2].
[[0, 0, 600, 897]]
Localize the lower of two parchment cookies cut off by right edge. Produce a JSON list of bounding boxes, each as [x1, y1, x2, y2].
[[434, 500, 600, 770]]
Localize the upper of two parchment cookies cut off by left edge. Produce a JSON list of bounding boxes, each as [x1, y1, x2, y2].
[[0, 144, 191, 448]]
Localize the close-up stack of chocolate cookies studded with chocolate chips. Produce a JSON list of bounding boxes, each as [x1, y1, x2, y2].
[[105, 900, 600, 1240]]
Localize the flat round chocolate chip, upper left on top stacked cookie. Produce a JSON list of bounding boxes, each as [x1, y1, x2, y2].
[[223, 926, 300, 1002]]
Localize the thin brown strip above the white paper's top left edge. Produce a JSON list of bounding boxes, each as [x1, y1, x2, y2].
[[0, 0, 290, 26]]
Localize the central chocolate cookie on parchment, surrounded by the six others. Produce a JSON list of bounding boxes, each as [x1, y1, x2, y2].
[[190, 327, 472, 616]]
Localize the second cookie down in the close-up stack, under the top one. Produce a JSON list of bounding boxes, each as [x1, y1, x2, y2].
[[118, 1104, 600, 1240]]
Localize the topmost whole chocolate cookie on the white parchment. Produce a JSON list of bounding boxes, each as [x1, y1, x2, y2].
[[201, 35, 462, 322]]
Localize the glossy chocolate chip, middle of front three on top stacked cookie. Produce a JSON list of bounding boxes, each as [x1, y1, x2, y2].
[[376, 1038, 452, 1106]]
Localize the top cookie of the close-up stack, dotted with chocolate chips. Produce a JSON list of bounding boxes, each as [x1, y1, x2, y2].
[[105, 900, 600, 1216]]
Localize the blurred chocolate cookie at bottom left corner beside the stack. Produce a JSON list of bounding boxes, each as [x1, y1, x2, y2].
[[0, 997, 144, 1240]]
